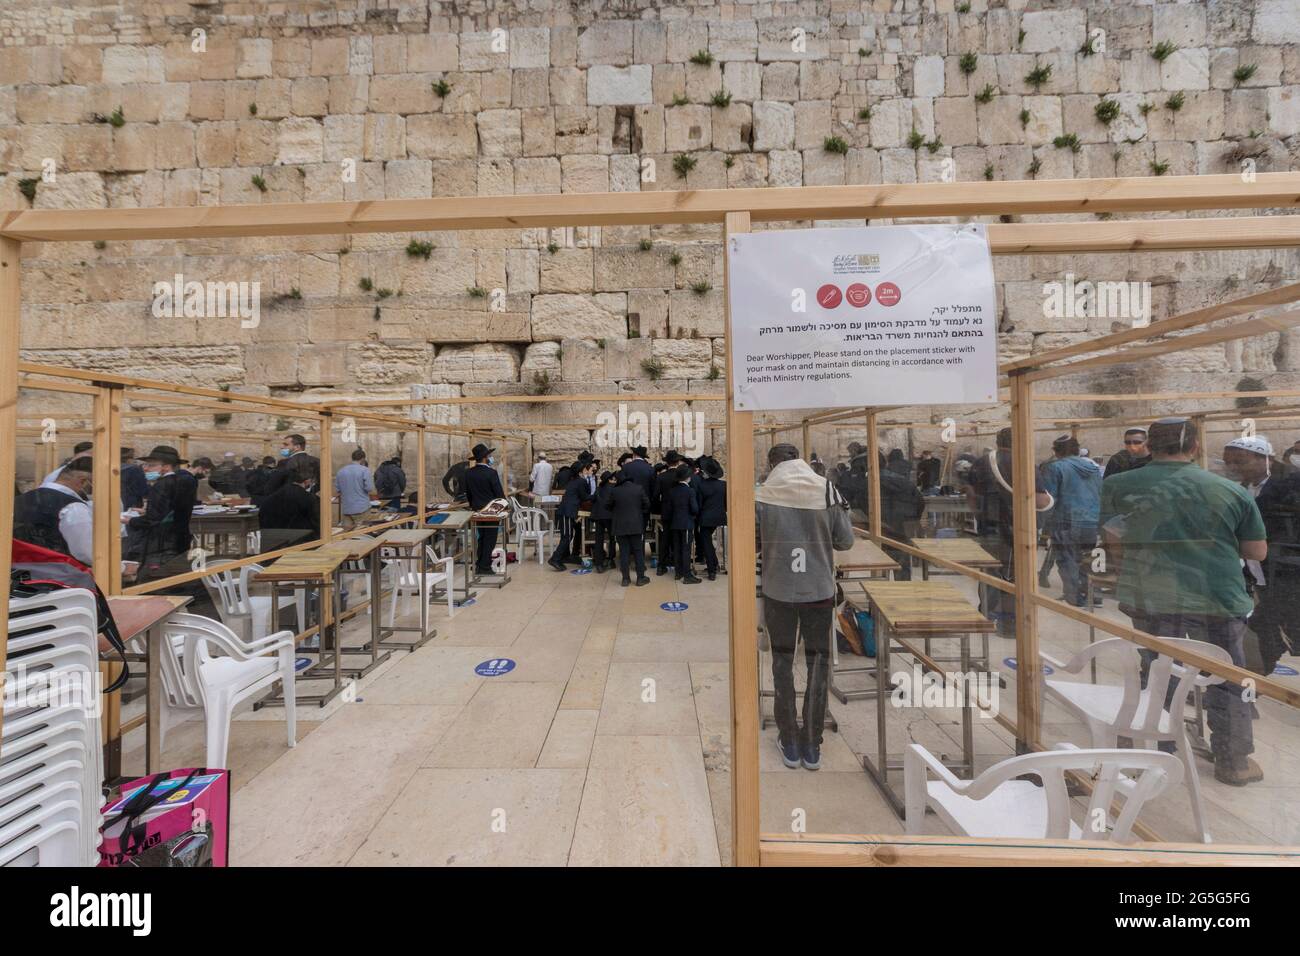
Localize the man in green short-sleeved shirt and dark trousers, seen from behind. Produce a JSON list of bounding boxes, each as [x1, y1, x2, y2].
[[1100, 418, 1268, 786]]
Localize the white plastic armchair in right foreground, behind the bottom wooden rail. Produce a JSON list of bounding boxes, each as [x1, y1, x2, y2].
[[904, 744, 1183, 843]]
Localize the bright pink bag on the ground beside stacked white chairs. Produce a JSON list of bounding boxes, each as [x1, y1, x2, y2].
[[99, 767, 230, 866]]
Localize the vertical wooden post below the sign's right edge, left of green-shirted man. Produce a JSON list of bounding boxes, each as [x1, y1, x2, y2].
[[1010, 372, 1043, 753]]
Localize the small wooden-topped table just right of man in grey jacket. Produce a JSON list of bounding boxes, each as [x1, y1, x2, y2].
[[861, 579, 993, 818]]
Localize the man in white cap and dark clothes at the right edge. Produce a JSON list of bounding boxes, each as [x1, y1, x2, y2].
[[1223, 436, 1300, 676]]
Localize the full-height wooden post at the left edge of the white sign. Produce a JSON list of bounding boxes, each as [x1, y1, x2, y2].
[[723, 212, 761, 866]]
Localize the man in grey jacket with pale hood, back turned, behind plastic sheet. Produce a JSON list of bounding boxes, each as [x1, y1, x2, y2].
[[754, 445, 853, 770]]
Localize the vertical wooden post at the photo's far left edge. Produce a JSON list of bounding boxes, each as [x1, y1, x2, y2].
[[0, 238, 20, 743]]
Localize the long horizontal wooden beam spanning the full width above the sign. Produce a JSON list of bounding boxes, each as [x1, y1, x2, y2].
[[0, 173, 1300, 242]]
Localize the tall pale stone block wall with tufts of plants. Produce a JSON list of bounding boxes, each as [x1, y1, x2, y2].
[[0, 0, 1300, 468]]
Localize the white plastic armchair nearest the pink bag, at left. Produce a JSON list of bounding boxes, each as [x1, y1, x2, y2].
[[160, 614, 298, 767]]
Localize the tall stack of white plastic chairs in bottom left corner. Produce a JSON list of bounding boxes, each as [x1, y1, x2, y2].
[[0, 589, 104, 866]]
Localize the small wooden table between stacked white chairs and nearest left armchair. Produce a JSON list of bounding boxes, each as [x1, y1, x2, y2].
[[101, 594, 192, 780]]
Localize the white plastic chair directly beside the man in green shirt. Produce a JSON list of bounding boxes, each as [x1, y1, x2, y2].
[[1040, 637, 1232, 843]]
